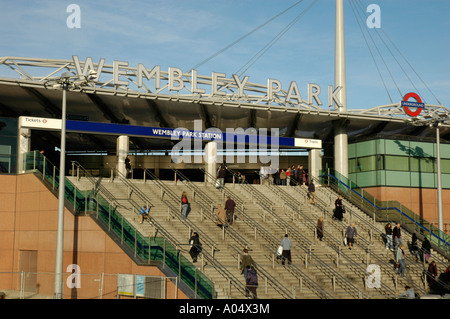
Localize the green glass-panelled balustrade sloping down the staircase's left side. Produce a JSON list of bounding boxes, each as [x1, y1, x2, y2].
[[24, 151, 215, 299]]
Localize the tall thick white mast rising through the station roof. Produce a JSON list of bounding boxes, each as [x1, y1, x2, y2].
[[334, 0, 348, 177]]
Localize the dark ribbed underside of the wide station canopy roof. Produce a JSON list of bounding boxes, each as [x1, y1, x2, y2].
[[0, 57, 450, 153]]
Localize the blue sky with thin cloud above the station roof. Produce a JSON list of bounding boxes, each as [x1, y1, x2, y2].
[[0, 0, 450, 109]]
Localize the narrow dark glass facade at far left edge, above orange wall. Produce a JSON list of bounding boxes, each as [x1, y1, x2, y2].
[[0, 118, 17, 174]]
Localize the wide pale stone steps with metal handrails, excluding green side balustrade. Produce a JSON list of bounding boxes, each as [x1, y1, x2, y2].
[[67, 162, 448, 299]]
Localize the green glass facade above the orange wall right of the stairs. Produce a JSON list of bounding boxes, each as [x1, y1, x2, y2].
[[348, 139, 450, 189]]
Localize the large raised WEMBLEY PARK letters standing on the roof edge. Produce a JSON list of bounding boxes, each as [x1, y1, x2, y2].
[[72, 55, 342, 108]]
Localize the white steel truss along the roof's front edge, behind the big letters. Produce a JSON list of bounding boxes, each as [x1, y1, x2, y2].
[[0, 57, 450, 121]]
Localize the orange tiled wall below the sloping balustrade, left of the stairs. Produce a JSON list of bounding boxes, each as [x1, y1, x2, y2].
[[0, 174, 186, 298]]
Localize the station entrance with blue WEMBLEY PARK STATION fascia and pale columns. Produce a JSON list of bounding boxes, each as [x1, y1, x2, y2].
[[17, 116, 322, 184]]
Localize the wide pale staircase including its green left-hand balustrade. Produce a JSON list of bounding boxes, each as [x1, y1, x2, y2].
[[25, 152, 448, 299]]
